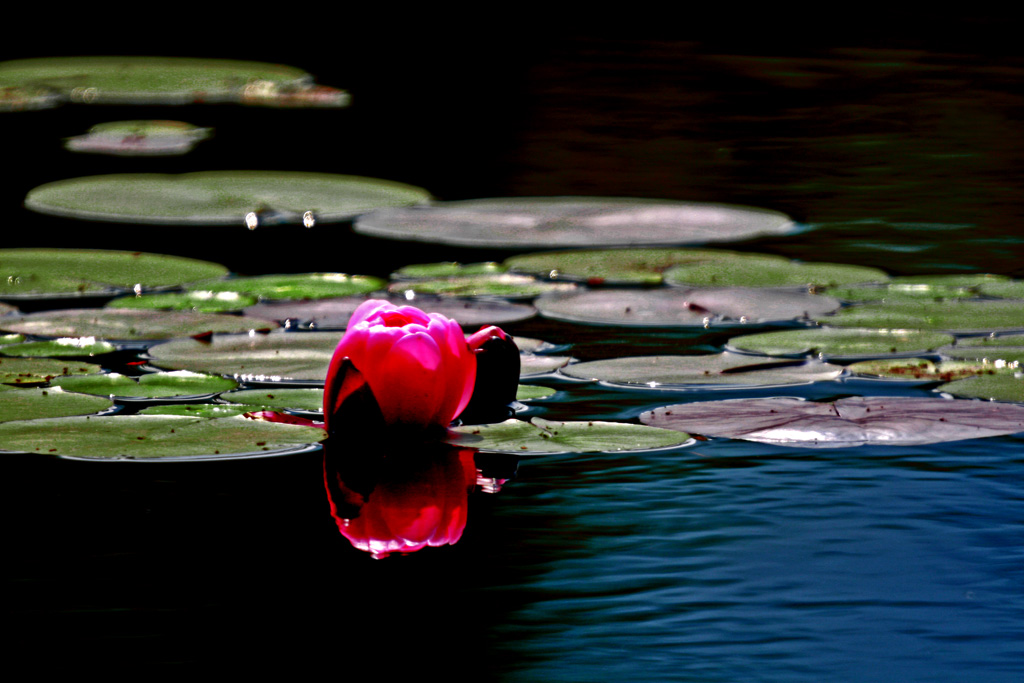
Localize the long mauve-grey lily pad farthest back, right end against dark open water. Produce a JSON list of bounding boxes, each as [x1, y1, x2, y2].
[[355, 197, 796, 249]]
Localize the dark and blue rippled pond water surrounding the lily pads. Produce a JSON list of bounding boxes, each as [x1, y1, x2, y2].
[[0, 30, 1024, 681]]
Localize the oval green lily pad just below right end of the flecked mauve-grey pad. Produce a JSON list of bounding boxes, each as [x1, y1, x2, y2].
[[729, 328, 952, 358]]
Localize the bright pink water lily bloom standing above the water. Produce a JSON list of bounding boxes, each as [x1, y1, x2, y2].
[[324, 299, 476, 431]]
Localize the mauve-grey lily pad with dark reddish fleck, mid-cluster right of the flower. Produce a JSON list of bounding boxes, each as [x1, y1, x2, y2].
[[536, 287, 840, 327]]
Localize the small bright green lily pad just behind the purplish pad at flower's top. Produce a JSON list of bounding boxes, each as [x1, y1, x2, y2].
[[193, 272, 387, 300]]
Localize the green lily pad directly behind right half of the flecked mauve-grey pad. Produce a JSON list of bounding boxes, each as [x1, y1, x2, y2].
[[665, 254, 888, 288]]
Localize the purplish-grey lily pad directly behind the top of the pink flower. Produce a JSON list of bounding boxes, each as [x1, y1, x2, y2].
[[244, 295, 537, 332]]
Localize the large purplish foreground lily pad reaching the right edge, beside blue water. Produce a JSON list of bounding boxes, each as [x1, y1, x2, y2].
[[640, 396, 1024, 449]]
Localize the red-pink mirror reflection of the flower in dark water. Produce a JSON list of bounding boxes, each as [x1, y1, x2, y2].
[[324, 450, 476, 559]]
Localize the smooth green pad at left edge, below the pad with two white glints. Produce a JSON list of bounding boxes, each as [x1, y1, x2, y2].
[[0, 249, 227, 299]]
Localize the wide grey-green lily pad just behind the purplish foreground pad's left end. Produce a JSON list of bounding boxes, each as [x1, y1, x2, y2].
[[561, 351, 843, 388]]
